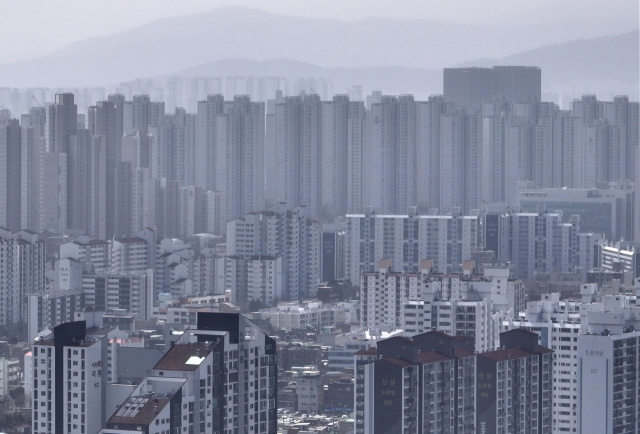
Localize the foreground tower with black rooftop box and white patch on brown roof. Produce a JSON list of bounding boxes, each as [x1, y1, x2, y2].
[[165, 312, 277, 434]]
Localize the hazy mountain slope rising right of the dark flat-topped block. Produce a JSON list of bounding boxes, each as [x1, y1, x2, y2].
[[458, 30, 640, 92]]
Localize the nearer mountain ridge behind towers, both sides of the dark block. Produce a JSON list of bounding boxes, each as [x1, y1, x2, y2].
[[170, 30, 640, 100]]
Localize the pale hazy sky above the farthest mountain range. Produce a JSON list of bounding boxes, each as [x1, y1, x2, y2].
[[0, 0, 638, 63]]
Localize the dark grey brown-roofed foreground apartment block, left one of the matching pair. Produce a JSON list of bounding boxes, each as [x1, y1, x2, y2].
[[355, 332, 476, 433]]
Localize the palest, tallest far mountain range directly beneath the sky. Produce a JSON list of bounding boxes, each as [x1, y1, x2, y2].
[[0, 7, 636, 87]]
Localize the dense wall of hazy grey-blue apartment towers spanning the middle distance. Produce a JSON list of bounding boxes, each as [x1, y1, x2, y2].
[[0, 67, 640, 241]]
